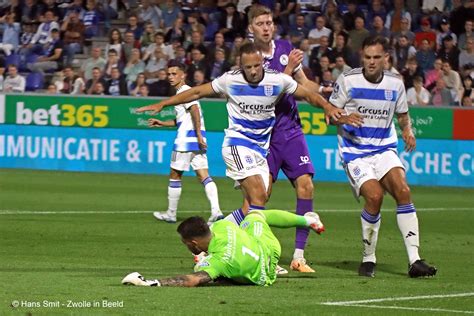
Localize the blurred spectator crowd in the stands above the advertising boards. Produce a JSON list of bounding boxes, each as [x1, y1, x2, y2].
[[0, 0, 474, 106]]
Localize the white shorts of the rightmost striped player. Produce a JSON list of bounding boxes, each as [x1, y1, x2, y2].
[[344, 150, 405, 200]]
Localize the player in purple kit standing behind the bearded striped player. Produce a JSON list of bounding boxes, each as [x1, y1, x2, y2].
[[248, 5, 326, 272]]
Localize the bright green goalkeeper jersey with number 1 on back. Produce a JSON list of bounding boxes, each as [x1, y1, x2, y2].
[[195, 220, 276, 285]]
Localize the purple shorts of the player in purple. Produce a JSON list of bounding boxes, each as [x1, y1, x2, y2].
[[267, 129, 314, 181]]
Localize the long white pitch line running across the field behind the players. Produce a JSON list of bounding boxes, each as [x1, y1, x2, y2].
[[0, 207, 474, 215]]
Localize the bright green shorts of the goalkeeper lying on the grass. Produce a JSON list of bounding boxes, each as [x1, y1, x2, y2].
[[240, 211, 281, 283]]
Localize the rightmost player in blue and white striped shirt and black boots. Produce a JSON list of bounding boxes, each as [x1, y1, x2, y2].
[[329, 36, 436, 277]]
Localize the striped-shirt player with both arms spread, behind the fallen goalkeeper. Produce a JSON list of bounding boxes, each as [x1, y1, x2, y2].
[[137, 43, 342, 222]]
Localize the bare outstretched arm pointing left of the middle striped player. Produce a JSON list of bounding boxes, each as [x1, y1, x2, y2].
[[136, 83, 215, 114]]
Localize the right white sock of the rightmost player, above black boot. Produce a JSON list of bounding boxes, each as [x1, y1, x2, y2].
[[397, 203, 420, 264]]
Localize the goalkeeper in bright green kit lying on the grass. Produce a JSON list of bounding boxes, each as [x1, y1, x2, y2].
[[122, 210, 324, 287]]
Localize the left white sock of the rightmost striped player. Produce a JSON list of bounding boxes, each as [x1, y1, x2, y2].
[[360, 209, 381, 263]]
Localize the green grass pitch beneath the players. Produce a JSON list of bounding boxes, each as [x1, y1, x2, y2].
[[0, 169, 474, 315]]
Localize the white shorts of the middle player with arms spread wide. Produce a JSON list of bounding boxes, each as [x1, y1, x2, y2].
[[222, 146, 270, 190]]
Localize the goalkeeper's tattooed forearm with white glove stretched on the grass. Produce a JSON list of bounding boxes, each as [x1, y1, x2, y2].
[[122, 271, 212, 287]]
